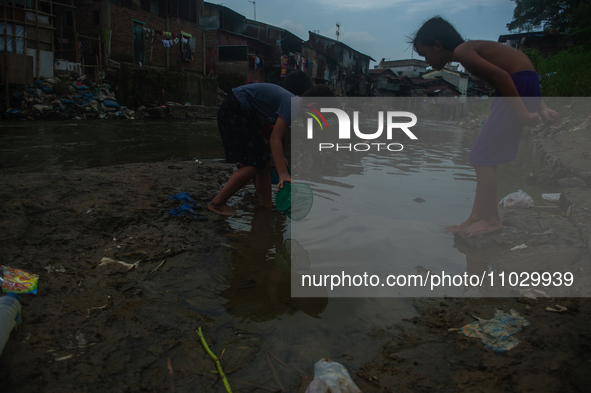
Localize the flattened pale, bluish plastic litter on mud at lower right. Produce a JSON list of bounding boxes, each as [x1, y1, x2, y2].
[[452, 309, 529, 352]]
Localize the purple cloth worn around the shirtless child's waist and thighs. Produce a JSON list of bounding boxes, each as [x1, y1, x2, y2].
[[468, 71, 542, 166]]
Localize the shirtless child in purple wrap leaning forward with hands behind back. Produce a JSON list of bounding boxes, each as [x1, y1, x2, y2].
[[412, 16, 557, 237]]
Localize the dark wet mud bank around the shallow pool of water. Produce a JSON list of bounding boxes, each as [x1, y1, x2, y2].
[[0, 110, 591, 392]]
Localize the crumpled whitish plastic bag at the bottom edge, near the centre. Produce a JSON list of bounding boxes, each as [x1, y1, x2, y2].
[[306, 358, 361, 393]]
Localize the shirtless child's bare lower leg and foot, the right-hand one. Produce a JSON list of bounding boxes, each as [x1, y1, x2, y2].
[[458, 166, 503, 237]]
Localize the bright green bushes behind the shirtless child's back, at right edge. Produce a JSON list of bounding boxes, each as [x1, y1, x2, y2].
[[528, 47, 591, 97]]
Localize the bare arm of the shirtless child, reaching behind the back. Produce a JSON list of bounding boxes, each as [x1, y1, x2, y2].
[[454, 44, 541, 126]]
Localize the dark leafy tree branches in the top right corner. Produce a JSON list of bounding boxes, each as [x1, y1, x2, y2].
[[507, 0, 591, 33]]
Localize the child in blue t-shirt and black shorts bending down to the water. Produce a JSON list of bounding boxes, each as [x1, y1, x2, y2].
[[207, 82, 334, 216]]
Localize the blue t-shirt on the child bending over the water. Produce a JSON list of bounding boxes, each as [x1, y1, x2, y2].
[[232, 83, 300, 125]]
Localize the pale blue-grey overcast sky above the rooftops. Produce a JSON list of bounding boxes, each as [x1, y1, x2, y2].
[[210, 0, 515, 68]]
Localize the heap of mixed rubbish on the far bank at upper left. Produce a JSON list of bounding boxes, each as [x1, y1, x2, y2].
[[2, 75, 135, 120]]
